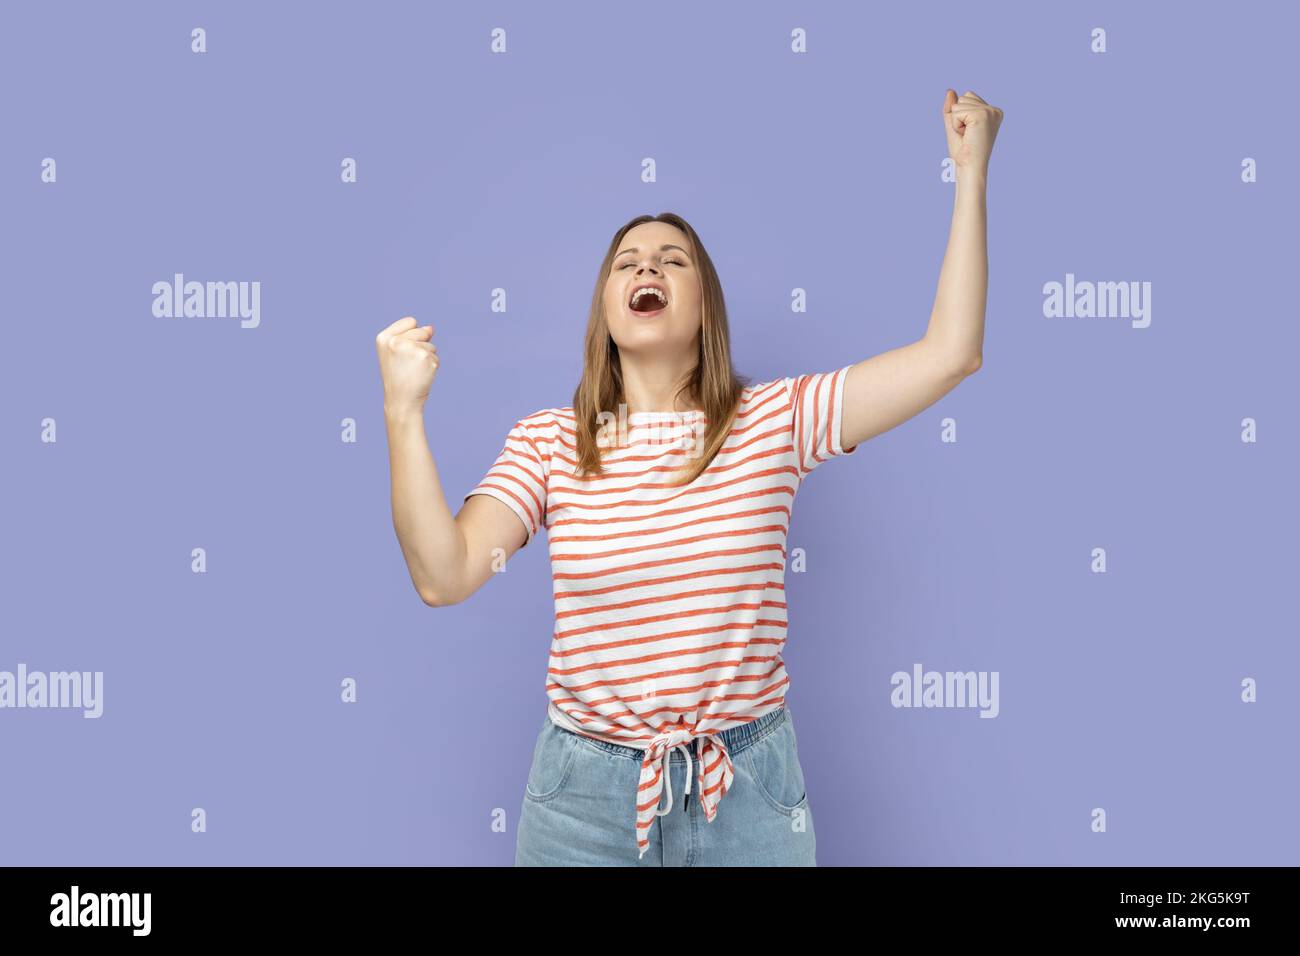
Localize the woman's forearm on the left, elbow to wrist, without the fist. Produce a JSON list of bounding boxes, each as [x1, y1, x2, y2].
[[384, 408, 465, 602]]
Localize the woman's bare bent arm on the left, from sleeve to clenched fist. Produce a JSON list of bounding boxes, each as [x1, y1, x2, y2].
[[376, 316, 527, 607]]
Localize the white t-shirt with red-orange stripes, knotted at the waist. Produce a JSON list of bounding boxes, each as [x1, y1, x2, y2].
[[465, 365, 854, 855]]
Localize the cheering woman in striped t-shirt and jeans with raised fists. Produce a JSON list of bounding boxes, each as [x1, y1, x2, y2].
[[376, 90, 1002, 866]]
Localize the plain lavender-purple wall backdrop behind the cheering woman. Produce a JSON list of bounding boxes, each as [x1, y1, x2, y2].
[[0, 3, 1300, 865]]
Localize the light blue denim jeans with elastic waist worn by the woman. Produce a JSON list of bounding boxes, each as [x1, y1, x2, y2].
[[515, 706, 816, 866]]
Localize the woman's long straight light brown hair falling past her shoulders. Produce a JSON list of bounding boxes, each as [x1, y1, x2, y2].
[[573, 212, 749, 485]]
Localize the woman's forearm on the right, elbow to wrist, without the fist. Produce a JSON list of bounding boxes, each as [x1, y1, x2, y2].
[[926, 169, 988, 369]]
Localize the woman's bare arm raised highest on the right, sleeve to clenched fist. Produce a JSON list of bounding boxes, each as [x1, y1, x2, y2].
[[840, 90, 1002, 447]]
